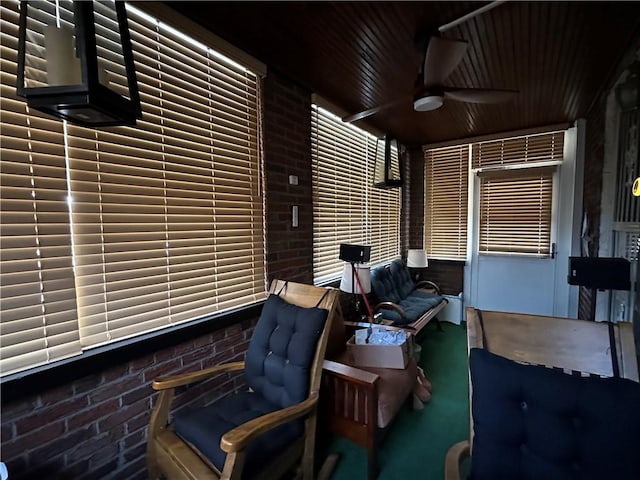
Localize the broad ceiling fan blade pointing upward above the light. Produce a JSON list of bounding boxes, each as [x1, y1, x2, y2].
[[423, 36, 469, 88]]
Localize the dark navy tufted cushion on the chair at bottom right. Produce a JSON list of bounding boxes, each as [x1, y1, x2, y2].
[[469, 349, 640, 480]]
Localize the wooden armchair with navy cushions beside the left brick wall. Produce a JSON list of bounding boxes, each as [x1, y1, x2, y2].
[[147, 280, 338, 480]]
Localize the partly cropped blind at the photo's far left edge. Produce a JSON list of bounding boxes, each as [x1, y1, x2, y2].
[[0, 2, 80, 375]]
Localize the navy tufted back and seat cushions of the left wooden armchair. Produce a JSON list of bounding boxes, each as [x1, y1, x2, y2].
[[173, 295, 327, 478]]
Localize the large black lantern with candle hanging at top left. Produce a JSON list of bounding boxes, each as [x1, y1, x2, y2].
[[16, 0, 142, 127]]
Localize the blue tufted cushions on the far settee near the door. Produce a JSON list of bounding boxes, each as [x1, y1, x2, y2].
[[371, 259, 442, 325]]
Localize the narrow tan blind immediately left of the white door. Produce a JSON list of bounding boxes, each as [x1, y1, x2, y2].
[[424, 145, 469, 260]]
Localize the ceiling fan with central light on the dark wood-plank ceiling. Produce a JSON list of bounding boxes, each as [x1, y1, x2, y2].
[[342, 0, 518, 123]]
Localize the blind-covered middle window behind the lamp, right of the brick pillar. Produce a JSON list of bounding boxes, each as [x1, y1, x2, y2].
[[311, 105, 400, 284]]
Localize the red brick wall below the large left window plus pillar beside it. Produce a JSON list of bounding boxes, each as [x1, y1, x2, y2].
[[0, 69, 313, 480]]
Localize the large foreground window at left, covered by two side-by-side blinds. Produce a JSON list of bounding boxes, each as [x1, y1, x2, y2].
[[0, 2, 265, 375]]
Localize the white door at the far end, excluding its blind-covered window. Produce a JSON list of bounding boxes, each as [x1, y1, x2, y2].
[[465, 122, 583, 317]]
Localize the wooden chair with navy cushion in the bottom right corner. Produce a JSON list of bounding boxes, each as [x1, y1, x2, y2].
[[445, 308, 640, 480]]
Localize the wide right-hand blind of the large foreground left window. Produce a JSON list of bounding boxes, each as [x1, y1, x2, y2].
[[69, 8, 265, 346]]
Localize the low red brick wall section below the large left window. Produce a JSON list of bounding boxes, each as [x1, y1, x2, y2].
[[2, 322, 253, 480]]
